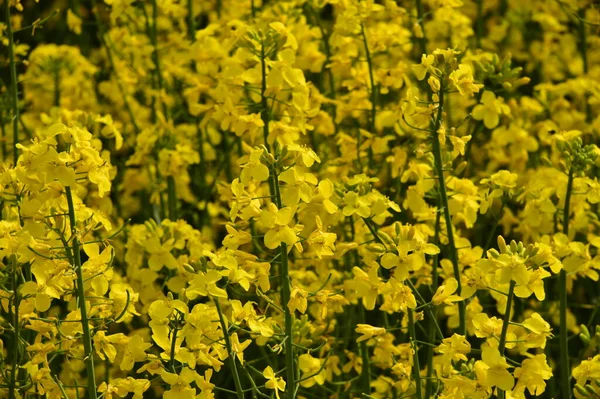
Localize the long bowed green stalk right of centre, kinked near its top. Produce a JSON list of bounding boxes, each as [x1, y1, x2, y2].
[[431, 75, 467, 335]]
